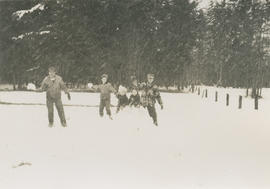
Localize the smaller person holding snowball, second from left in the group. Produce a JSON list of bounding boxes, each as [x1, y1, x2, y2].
[[90, 74, 116, 119]]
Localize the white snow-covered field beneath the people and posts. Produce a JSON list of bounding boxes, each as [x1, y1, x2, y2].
[[0, 88, 270, 189]]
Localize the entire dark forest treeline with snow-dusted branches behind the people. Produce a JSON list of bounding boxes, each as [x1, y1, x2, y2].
[[0, 0, 270, 93]]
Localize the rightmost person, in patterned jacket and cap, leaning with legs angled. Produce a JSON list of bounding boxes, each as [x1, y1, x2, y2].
[[141, 74, 163, 126]]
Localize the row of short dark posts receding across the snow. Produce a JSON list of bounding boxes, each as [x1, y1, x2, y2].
[[191, 86, 259, 110]]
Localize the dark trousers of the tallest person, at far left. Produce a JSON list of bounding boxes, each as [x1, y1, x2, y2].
[[47, 97, 66, 124]]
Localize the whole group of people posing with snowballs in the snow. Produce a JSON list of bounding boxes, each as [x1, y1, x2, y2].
[[37, 67, 163, 127]]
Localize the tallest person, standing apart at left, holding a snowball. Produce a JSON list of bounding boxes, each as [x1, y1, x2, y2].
[[37, 66, 71, 127]]
